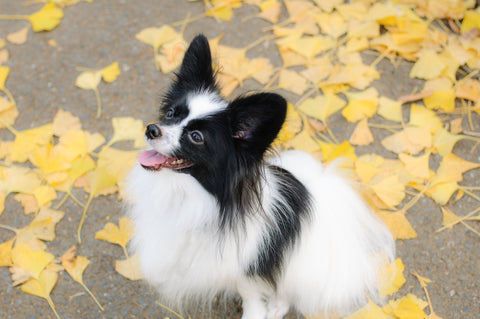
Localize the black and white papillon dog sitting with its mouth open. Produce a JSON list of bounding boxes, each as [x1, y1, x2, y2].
[[127, 35, 394, 319]]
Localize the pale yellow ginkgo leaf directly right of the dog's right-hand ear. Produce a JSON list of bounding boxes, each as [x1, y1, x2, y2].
[[298, 93, 347, 123]]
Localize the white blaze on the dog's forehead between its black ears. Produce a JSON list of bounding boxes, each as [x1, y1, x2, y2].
[[182, 92, 228, 123]]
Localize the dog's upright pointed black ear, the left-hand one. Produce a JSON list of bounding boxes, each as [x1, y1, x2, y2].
[[177, 34, 215, 90]]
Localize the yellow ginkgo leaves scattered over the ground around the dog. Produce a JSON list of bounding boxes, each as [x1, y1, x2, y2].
[[0, 0, 480, 319]]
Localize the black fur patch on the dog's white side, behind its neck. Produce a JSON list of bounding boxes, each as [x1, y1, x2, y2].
[[247, 166, 311, 287]]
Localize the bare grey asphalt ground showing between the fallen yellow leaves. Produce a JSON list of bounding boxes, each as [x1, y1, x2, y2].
[[0, 0, 480, 319]]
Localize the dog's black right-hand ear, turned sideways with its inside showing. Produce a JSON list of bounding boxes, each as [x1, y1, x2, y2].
[[228, 93, 287, 157]]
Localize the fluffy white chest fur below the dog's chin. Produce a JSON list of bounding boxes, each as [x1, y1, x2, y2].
[[128, 167, 261, 301]]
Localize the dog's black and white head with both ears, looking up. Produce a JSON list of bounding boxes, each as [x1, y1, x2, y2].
[[139, 35, 286, 195]]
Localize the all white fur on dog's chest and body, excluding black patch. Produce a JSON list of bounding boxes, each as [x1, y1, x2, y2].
[[128, 151, 394, 319]]
